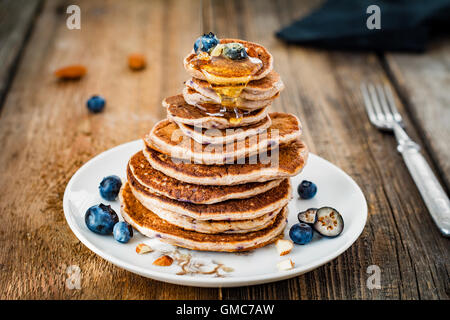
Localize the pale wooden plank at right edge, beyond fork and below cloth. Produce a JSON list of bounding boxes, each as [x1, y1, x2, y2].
[[385, 43, 450, 192]]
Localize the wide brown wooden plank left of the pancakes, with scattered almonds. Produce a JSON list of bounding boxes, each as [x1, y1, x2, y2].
[[0, 0, 218, 299]]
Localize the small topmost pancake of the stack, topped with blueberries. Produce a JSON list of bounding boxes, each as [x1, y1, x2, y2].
[[183, 39, 273, 84]]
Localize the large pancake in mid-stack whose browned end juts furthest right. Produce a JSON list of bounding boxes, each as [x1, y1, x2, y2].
[[143, 140, 308, 186]]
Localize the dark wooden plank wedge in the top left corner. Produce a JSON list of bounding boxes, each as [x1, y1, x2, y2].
[[0, 0, 42, 110]]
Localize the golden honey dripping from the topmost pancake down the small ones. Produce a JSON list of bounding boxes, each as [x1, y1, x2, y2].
[[191, 53, 262, 125]]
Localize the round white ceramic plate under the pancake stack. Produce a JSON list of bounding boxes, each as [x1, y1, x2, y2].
[[64, 140, 367, 287]]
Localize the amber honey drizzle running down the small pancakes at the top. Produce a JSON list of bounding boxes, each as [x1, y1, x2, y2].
[[191, 51, 262, 125]]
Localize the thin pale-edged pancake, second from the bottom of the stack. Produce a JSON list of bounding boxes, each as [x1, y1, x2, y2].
[[145, 208, 282, 234]]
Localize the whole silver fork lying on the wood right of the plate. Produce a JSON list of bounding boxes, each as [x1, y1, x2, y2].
[[361, 83, 450, 237]]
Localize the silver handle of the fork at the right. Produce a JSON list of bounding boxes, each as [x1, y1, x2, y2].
[[394, 128, 450, 237]]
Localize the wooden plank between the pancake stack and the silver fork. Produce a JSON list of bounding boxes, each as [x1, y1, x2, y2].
[[213, 1, 450, 299]]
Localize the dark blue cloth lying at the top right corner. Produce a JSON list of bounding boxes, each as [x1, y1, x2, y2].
[[276, 0, 450, 52]]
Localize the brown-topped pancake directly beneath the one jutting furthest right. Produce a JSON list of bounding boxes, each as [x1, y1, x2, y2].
[[127, 151, 282, 204]]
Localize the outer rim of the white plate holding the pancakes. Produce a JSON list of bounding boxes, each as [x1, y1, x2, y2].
[[63, 139, 368, 288]]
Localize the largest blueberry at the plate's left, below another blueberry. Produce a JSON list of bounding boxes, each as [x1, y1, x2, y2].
[[84, 203, 119, 234]]
